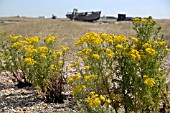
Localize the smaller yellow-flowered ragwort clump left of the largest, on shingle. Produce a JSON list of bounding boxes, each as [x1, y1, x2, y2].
[[2, 34, 69, 102]]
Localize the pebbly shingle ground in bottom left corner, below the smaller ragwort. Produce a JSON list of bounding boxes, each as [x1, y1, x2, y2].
[[0, 75, 74, 113]]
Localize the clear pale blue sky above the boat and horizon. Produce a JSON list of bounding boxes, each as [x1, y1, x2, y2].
[[0, 0, 170, 19]]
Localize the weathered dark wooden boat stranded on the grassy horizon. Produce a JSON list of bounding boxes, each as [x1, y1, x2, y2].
[[66, 9, 101, 22]]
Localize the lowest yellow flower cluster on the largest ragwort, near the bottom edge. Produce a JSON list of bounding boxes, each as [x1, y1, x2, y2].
[[85, 91, 111, 107]]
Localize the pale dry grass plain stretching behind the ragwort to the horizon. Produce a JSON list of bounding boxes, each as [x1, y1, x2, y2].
[[0, 18, 170, 59]]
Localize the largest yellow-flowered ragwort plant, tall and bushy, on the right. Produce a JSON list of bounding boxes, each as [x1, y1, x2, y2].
[[68, 17, 169, 113]]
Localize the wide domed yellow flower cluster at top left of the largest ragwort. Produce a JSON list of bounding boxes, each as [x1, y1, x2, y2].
[[76, 32, 103, 46]]
